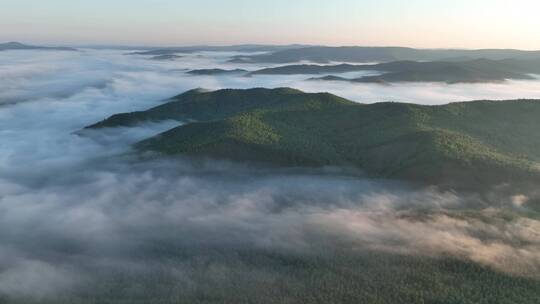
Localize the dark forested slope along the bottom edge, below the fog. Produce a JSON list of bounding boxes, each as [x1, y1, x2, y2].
[[11, 247, 540, 304]]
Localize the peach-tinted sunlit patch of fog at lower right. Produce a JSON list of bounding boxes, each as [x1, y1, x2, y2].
[[315, 210, 540, 276]]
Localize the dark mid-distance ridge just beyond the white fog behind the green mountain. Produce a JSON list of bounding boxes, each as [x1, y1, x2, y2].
[[249, 59, 540, 83]]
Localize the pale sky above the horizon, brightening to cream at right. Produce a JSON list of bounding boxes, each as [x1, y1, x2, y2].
[[0, 0, 540, 49]]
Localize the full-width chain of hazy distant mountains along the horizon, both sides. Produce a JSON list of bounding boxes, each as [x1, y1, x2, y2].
[[6, 42, 540, 67]]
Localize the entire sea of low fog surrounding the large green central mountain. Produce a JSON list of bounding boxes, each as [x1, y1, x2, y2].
[[0, 50, 540, 299]]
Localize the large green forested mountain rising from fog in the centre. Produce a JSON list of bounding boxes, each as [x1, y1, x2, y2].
[[88, 88, 540, 186]]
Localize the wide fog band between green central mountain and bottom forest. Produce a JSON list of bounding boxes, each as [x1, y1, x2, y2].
[[0, 160, 540, 298]]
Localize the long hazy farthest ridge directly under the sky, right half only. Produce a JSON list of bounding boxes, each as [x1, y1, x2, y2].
[[231, 46, 540, 63]]
